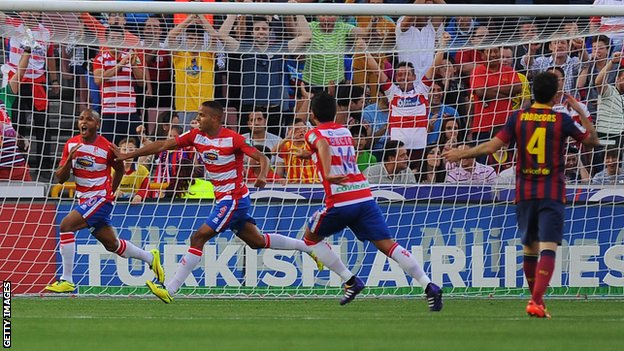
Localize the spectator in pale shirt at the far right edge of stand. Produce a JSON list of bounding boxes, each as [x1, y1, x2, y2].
[[596, 52, 624, 148]]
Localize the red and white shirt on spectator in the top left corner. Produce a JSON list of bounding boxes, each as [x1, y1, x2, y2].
[[6, 18, 54, 79]]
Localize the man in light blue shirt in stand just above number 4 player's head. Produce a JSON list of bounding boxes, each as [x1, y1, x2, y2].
[[521, 38, 589, 94]]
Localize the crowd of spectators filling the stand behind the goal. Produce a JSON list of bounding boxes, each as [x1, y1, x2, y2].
[[0, 0, 624, 203]]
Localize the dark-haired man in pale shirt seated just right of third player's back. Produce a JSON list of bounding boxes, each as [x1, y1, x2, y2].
[[362, 140, 416, 185]]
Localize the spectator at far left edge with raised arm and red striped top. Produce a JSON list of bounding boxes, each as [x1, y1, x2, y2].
[[0, 47, 32, 181]]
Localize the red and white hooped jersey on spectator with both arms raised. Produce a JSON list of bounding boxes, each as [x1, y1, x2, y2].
[[382, 77, 431, 150]]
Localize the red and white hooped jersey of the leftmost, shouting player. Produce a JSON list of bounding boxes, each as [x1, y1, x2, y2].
[[61, 135, 115, 203]]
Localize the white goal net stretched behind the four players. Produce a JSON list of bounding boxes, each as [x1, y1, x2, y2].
[[0, 1, 624, 296]]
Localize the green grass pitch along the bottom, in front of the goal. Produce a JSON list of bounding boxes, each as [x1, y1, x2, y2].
[[11, 297, 624, 351]]
